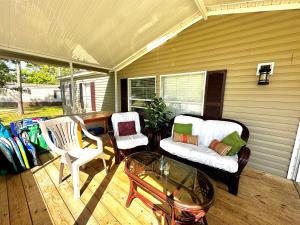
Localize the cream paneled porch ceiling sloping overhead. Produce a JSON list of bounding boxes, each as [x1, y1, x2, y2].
[[0, 0, 300, 69]]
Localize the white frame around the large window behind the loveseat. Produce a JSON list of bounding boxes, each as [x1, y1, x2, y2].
[[159, 71, 207, 115]]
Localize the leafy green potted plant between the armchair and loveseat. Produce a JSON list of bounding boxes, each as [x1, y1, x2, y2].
[[145, 96, 171, 146]]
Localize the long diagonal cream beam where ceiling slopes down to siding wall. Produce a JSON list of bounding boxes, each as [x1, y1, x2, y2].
[[114, 12, 203, 71]]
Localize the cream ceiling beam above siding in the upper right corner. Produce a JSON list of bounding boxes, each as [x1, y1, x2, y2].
[[208, 3, 300, 16]]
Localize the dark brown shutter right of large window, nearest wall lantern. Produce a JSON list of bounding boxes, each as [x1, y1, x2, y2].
[[203, 70, 227, 119]]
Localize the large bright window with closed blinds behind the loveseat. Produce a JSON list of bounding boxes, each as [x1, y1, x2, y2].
[[161, 72, 206, 115]]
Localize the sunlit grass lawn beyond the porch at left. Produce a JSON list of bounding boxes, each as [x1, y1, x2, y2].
[[0, 106, 63, 126]]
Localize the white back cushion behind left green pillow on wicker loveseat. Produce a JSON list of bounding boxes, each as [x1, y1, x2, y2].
[[172, 115, 204, 144]]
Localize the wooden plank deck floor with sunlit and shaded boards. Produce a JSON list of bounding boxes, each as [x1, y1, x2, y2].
[[0, 134, 300, 225]]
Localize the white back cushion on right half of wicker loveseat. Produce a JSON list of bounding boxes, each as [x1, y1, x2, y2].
[[200, 120, 243, 147]]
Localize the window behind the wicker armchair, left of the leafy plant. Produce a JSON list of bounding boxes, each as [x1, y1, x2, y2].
[[128, 77, 155, 112]]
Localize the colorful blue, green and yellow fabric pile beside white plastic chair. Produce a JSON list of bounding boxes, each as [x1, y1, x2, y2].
[[0, 118, 48, 175]]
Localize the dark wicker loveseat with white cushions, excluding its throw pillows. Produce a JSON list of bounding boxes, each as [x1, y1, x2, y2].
[[160, 115, 250, 195]]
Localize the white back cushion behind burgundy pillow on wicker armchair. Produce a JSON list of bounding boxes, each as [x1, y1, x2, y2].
[[111, 112, 141, 136]]
